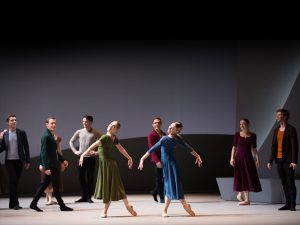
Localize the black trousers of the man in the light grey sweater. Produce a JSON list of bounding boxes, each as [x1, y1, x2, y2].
[[78, 157, 96, 199]]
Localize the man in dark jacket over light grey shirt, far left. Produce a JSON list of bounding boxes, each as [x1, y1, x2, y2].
[[0, 114, 30, 210]]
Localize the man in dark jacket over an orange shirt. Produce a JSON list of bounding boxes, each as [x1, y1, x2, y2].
[[268, 109, 298, 211]]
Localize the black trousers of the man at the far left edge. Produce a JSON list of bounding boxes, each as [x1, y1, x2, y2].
[[5, 159, 23, 208]]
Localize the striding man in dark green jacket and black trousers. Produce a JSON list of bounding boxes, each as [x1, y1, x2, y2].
[[30, 117, 73, 212]]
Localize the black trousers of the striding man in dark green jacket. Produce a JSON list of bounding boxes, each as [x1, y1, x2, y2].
[[31, 168, 65, 207]]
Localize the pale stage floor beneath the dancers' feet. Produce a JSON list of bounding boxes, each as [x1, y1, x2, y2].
[[0, 194, 300, 225]]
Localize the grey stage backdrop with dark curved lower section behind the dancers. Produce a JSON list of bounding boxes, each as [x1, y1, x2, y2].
[[0, 40, 300, 193]]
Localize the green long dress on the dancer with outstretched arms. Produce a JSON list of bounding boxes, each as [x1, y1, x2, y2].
[[94, 134, 126, 203]]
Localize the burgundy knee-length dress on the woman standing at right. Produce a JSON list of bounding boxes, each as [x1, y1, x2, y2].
[[233, 132, 262, 192]]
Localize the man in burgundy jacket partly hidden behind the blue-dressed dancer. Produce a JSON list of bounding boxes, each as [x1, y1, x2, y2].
[[148, 117, 166, 203]]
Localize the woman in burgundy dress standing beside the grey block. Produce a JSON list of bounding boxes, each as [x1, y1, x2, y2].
[[230, 119, 262, 205]]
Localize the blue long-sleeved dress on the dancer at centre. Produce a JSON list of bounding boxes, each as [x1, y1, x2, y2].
[[148, 136, 193, 200]]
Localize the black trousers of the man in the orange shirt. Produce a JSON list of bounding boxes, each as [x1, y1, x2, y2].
[[277, 159, 297, 206]]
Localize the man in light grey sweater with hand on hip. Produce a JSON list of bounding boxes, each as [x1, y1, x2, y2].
[[69, 115, 101, 203]]
